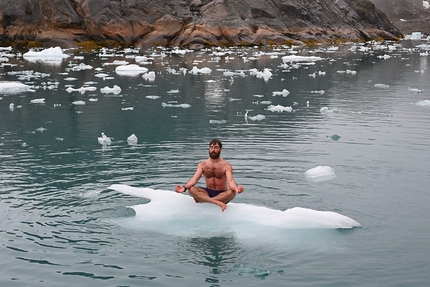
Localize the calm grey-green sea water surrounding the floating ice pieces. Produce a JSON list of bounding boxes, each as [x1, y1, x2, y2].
[[0, 41, 430, 286]]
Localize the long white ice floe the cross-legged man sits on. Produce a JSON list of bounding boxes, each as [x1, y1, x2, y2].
[[110, 187, 361, 234]]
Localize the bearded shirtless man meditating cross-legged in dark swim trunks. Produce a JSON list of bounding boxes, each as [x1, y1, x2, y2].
[[175, 139, 245, 211]]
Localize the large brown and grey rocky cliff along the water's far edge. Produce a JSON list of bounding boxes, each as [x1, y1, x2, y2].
[[0, 0, 402, 48]]
